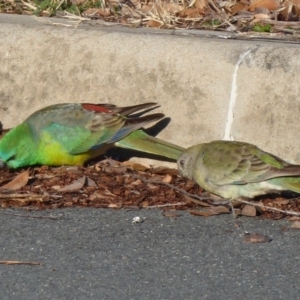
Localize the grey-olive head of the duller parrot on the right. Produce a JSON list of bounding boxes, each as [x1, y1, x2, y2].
[[177, 146, 198, 179]]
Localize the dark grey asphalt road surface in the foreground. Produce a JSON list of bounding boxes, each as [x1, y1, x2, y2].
[[0, 208, 300, 300]]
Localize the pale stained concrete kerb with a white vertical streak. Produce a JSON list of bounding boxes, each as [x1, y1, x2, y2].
[[0, 15, 300, 163]]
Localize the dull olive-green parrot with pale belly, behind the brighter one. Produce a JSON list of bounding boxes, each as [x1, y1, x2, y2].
[[177, 141, 300, 200]]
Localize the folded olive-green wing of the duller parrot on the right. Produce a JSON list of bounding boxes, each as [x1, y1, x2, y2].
[[202, 141, 300, 185]]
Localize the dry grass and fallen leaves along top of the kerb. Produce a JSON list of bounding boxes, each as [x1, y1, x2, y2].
[[0, 0, 300, 35]]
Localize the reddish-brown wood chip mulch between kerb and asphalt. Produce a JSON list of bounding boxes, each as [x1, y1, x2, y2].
[[0, 159, 300, 221]]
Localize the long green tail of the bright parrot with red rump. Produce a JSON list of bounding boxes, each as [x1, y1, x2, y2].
[[115, 130, 185, 160]]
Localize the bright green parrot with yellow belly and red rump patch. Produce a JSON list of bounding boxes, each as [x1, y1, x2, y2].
[[0, 102, 184, 169]]
